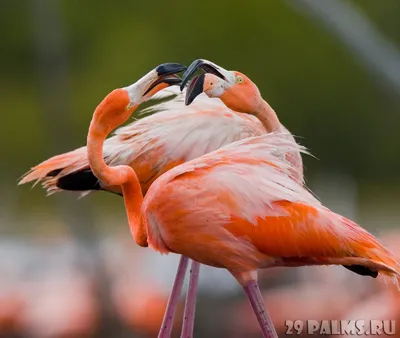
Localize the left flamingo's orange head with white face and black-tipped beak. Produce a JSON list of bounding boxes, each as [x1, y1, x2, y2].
[[94, 63, 186, 132]]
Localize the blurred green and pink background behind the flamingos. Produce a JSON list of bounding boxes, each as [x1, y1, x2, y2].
[[0, 0, 400, 338]]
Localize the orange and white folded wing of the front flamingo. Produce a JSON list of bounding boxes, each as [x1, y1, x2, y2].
[[144, 133, 400, 284]]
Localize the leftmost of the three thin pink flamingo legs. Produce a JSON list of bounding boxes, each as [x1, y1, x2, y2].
[[158, 256, 189, 338]]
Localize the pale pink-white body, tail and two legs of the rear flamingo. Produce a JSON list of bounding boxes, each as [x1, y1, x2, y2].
[[20, 62, 302, 337]]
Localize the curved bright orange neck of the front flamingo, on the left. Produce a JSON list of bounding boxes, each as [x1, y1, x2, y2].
[[87, 101, 148, 246]]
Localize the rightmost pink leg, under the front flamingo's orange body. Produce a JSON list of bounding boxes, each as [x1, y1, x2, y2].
[[243, 280, 278, 338]]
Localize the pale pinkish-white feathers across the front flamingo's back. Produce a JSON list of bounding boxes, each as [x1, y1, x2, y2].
[[145, 133, 314, 223]]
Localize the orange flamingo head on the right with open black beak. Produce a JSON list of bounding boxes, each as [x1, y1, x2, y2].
[[181, 59, 262, 114]]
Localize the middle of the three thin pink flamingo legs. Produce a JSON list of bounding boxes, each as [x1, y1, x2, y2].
[[181, 261, 200, 338]]
